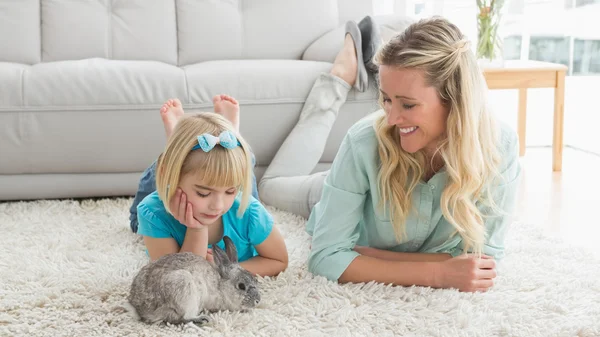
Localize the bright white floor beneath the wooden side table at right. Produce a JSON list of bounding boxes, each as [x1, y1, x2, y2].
[[516, 147, 600, 257]]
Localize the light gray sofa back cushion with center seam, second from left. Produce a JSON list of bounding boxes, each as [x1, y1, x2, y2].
[[38, 0, 177, 65]]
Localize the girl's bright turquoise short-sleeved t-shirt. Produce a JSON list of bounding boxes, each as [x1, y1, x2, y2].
[[137, 191, 273, 262]]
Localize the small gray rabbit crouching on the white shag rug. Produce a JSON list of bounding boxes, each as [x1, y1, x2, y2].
[[128, 236, 260, 325]]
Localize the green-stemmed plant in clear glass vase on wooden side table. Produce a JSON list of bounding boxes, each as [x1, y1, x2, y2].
[[477, 0, 504, 60]]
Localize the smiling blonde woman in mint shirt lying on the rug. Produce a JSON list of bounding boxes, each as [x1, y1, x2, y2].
[[259, 18, 521, 291]]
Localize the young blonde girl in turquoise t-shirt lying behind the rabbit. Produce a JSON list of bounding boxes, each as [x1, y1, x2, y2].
[[137, 99, 288, 276]]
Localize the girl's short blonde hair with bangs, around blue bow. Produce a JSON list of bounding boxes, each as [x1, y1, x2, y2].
[[156, 112, 252, 217]]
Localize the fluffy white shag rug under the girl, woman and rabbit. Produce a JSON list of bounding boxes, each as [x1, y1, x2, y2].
[[0, 198, 600, 337]]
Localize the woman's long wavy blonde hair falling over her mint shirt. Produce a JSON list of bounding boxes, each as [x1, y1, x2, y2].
[[375, 17, 500, 254]]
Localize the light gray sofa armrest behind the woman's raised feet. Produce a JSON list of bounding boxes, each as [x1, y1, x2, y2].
[[302, 15, 415, 63]]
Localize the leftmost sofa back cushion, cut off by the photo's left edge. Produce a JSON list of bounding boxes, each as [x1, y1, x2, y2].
[[0, 0, 40, 64]]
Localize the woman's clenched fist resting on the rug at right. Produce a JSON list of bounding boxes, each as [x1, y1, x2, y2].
[[435, 254, 496, 292]]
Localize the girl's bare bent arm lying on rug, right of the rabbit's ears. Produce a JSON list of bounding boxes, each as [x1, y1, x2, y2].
[[240, 226, 288, 276]]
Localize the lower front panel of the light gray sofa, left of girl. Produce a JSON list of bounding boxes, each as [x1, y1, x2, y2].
[[0, 105, 165, 175]]
